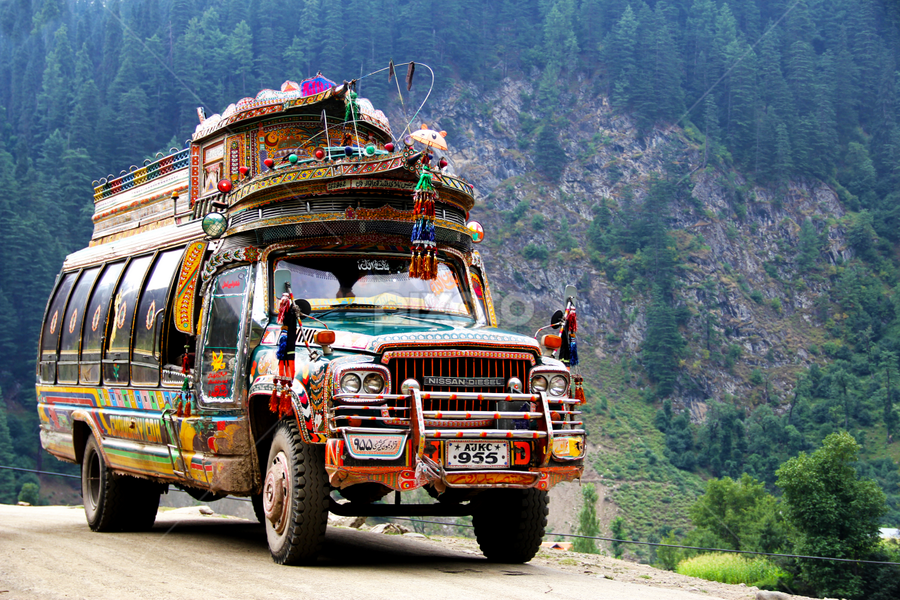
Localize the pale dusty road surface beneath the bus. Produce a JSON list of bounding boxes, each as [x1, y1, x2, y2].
[[0, 505, 800, 600]]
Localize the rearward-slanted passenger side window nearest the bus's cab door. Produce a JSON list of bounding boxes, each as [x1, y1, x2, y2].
[[131, 248, 184, 385]]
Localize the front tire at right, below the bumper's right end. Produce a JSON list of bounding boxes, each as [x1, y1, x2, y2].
[[472, 489, 550, 564]]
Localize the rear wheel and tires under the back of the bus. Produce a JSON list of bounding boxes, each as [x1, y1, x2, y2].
[[81, 435, 162, 531]]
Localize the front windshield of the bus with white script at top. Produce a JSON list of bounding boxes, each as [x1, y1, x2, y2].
[[273, 255, 471, 316]]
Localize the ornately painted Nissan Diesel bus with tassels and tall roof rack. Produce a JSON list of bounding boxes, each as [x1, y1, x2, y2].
[[37, 64, 585, 564]]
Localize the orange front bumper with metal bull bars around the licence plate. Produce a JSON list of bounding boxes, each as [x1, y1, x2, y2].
[[325, 390, 586, 490]]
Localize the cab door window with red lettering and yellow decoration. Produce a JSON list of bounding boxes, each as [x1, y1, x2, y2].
[[200, 267, 250, 404]]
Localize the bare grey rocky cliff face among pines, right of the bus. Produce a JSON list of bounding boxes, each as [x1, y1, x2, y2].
[[402, 80, 850, 419]]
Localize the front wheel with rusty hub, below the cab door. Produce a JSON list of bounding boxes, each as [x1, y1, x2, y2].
[[262, 420, 330, 565]]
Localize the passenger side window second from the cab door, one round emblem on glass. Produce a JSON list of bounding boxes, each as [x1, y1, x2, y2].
[[103, 256, 153, 384]]
